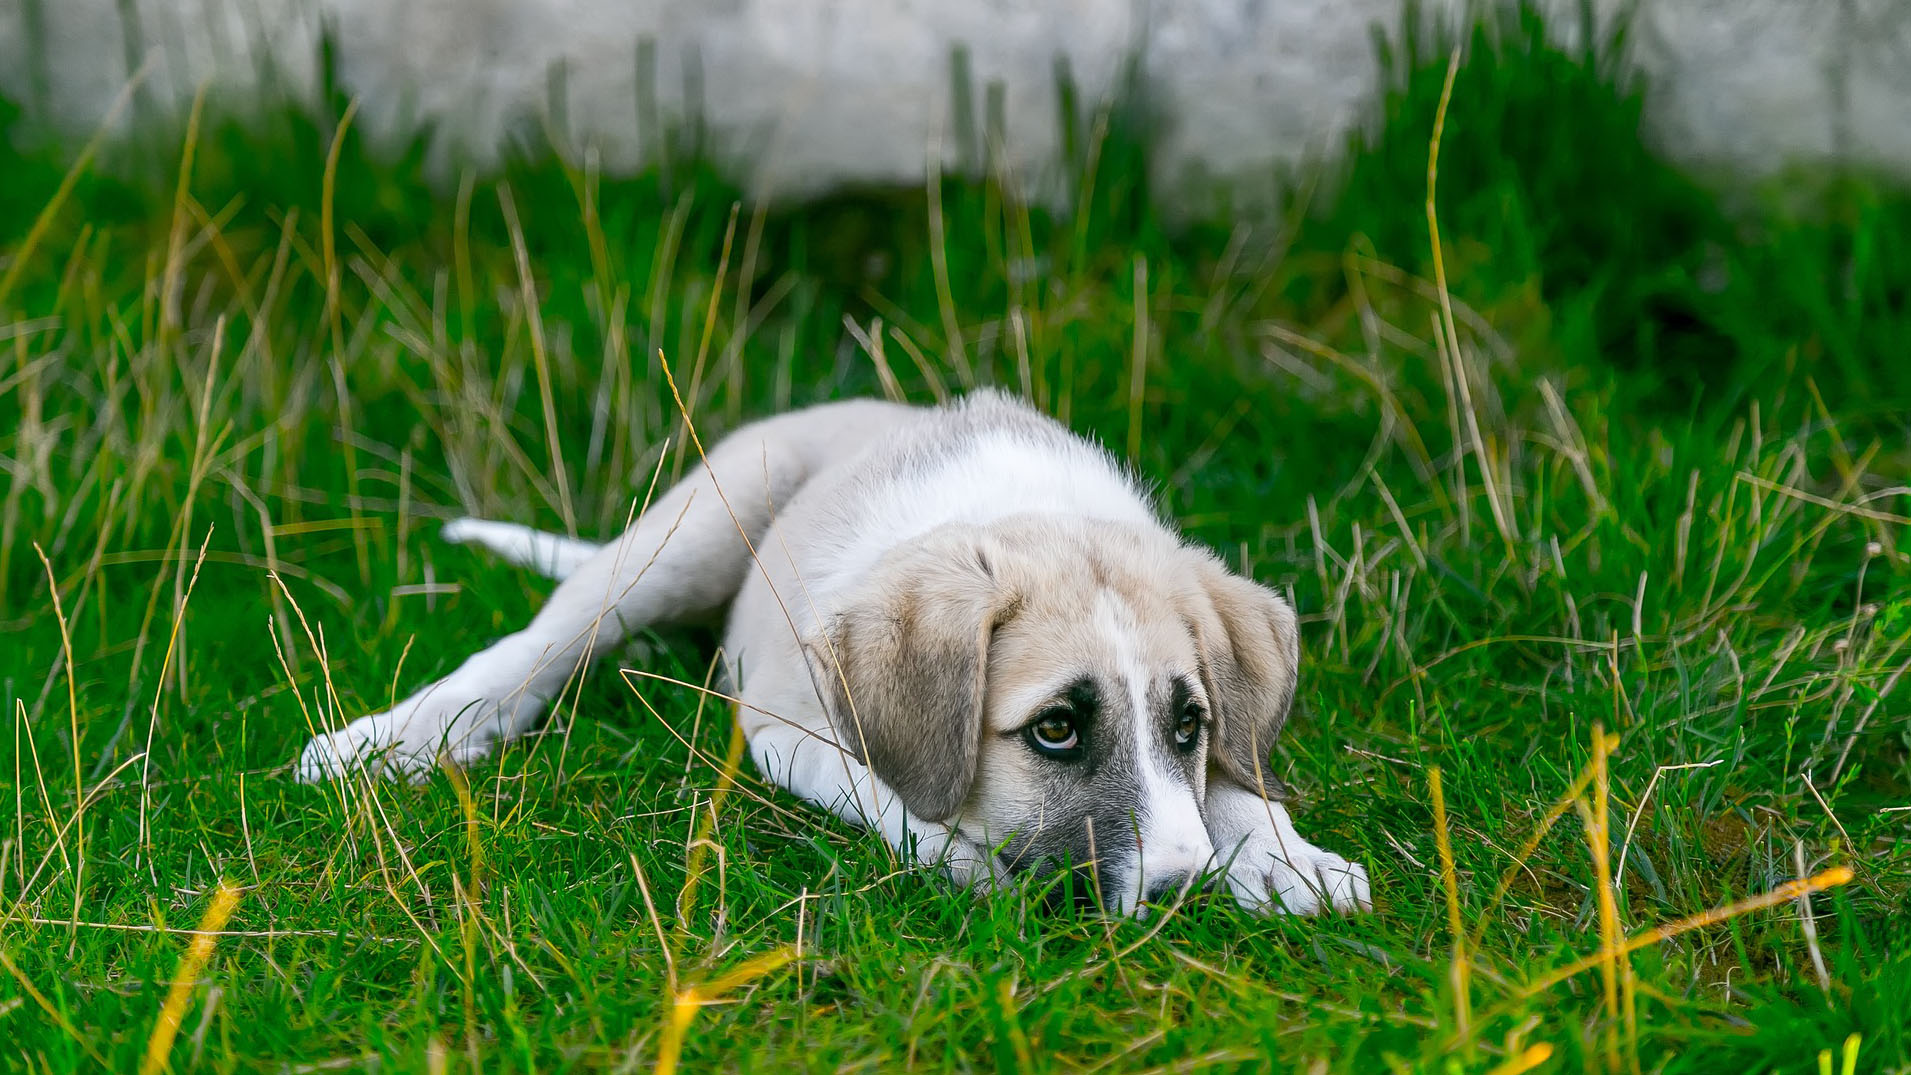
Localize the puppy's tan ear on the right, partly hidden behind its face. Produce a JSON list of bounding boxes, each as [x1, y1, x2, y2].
[[1189, 554, 1301, 798]]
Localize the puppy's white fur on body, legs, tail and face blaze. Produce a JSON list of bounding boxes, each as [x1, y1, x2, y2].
[[298, 393, 1368, 913]]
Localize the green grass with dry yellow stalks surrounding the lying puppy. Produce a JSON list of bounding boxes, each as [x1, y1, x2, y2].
[[0, 6, 1911, 1071]]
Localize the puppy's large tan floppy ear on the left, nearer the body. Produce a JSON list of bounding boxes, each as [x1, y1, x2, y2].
[[805, 529, 1011, 821]]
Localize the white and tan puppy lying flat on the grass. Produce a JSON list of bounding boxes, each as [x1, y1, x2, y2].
[[298, 390, 1370, 915]]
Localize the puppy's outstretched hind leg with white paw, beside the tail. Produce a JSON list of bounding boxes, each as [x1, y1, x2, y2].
[[298, 403, 915, 781]]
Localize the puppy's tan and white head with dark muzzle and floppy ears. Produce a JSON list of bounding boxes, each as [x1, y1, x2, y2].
[[805, 517, 1299, 911]]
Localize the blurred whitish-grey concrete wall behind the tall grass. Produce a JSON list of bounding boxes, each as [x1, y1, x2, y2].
[[0, 0, 1911, 197]]
